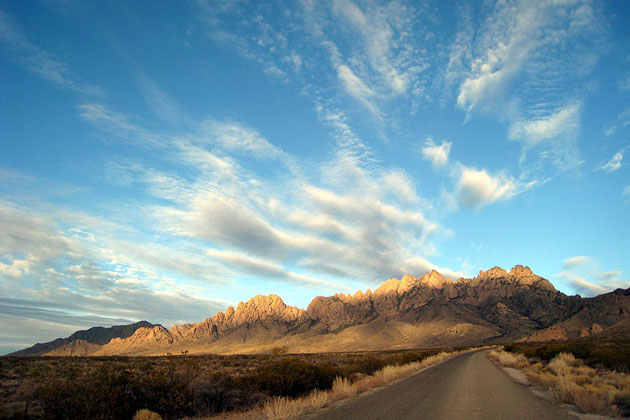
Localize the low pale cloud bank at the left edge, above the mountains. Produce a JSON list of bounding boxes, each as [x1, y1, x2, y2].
[[0, 203, 232, 350]]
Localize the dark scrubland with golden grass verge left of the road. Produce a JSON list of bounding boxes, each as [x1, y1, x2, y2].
[[0, 349, 464, 420]]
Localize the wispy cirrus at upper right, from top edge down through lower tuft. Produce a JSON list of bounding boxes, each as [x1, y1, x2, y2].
[[449, 0, 604, 170]]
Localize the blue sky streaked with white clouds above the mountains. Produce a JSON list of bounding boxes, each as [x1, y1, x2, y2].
[[0, 0, 630, 354]]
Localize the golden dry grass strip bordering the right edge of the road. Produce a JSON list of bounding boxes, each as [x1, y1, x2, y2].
[[489, 350, 630, 416]]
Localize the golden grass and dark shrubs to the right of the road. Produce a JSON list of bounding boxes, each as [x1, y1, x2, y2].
[[489, 343, 630, 417]]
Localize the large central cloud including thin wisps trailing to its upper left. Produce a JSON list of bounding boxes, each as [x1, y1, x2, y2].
[[71, 97, 461, 287]]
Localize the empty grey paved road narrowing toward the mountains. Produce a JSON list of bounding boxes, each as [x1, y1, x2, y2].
[[315, 351, 575, 420]]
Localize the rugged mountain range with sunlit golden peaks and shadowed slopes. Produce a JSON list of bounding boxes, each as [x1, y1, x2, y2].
[[13, 265, 630, 356]]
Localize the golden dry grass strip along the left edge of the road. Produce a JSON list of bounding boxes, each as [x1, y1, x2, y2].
[[261, 352, 470, 420]]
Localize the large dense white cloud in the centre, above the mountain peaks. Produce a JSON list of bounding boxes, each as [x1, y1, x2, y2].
[[132, 114, 459, 287]]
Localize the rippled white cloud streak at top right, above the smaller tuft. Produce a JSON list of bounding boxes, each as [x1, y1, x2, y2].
[[451, 0, 600, 114]]
